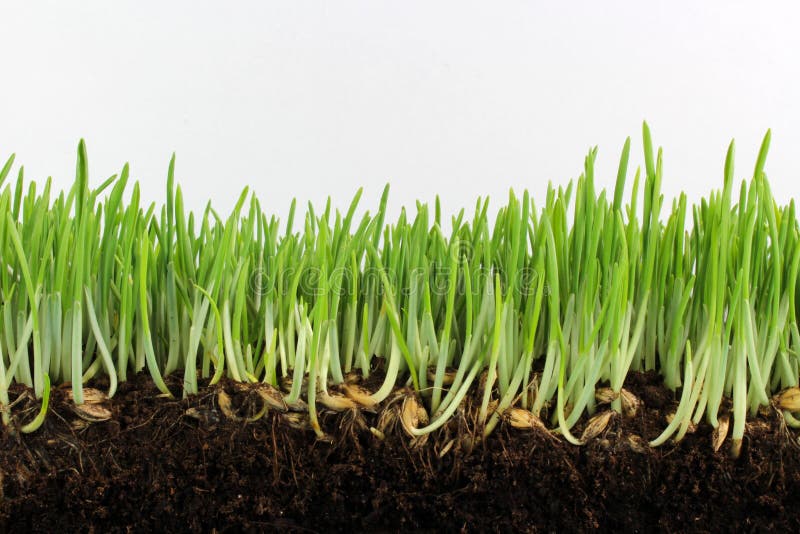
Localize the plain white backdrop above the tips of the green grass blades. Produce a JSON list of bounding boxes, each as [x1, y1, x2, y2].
[[0, 0, 800, 226]]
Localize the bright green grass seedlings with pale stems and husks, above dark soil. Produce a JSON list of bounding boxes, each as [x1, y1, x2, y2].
[[0, 125, 800, 457]]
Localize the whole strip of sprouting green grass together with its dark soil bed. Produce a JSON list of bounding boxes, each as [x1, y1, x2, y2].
[[0, 124, 800, 531]]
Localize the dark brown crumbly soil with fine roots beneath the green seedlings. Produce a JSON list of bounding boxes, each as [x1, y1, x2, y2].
[[0, 374, 800, 532]]
